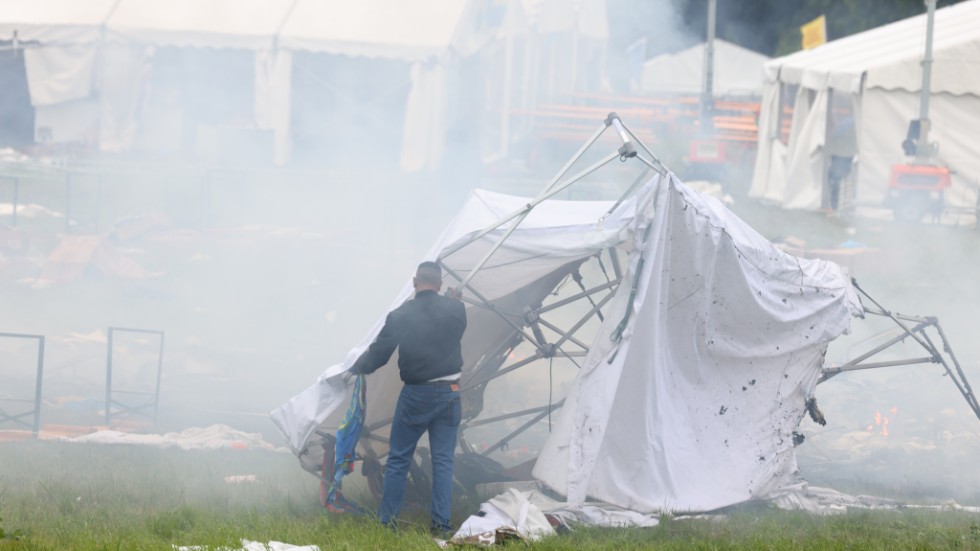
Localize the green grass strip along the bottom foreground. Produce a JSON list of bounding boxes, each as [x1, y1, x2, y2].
[[0, 441, 980, 551]]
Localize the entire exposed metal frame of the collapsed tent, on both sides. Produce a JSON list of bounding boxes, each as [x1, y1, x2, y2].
[[350, 112, 980, 484]]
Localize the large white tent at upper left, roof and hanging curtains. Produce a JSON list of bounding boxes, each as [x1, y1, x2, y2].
[[0, 0, 473, 169]]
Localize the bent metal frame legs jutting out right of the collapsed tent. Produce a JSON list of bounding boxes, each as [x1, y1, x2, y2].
[[817, 279, 980, 419]]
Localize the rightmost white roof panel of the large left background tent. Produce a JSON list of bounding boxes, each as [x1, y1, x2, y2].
[[279, 0, 468, 61]]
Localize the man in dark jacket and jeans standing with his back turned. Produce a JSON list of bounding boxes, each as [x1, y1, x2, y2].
[[351, 262, 466, 534]]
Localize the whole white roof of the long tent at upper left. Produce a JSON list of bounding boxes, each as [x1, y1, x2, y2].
[[0, 0, 470, 61]]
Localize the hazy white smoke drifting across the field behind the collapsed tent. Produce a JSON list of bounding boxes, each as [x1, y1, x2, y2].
[[0, 0, 980, 508]]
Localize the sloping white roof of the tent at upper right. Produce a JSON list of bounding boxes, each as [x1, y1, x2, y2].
[[765, 0, 980, 94]]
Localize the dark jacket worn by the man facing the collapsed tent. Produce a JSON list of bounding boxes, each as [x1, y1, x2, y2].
[[351, 291, 466, 384]]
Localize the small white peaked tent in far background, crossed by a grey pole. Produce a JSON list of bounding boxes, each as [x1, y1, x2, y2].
[[640, 39, 769, 96]]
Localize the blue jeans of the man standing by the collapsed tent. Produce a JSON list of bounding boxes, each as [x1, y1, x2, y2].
[[378, 382, 461, 531]]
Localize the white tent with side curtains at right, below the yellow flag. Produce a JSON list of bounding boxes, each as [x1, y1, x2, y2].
[[749, 0, 980, 213]]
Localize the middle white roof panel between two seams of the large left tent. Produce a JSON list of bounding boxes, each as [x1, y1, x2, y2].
[[106, 0, 295, 50]]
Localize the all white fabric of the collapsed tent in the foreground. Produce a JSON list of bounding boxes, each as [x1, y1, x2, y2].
[[271, 119, 862, 513]]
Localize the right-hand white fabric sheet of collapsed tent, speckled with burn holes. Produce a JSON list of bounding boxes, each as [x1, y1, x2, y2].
[[533, 178, 862, 512]]
